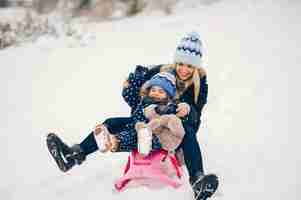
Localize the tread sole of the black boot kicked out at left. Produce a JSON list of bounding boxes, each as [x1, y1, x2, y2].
[[46, 133, 70, 172]]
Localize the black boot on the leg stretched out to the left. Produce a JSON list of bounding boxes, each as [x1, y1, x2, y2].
[[47, 133, 86, 172]]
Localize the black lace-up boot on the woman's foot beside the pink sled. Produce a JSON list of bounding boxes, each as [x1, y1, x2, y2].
[[189, 173, 218, 200]]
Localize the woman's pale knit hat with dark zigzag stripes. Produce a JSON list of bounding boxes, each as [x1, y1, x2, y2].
[[174, 31, 202, 67]]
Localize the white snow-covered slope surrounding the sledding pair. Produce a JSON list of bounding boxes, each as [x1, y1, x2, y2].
[[0, 0, 301, 200]]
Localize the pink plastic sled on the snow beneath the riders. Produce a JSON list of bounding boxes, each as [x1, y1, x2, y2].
[[115, 149, 182, 191]]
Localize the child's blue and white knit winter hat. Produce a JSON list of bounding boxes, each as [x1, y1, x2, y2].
[[144, 72, 176, 98]]
